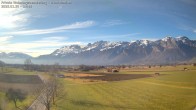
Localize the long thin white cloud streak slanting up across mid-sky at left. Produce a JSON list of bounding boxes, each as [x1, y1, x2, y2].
[[4, 21, 95, 35]]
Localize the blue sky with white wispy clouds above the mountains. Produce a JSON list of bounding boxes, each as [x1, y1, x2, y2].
[[0, 0, 196, 57]]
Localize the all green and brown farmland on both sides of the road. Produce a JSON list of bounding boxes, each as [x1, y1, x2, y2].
[[0, 65, 196, 110]]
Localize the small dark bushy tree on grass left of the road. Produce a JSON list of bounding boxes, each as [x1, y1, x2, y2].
[[6, 89, 26, 108]]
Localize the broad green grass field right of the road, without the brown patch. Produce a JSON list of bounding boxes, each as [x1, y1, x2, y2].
[[54, 66, 196, 110]]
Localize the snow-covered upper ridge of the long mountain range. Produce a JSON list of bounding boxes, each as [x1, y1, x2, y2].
[[52, 36, 192, 56]]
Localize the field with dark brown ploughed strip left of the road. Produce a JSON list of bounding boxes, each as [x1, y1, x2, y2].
[[0, 68, 42, 110]]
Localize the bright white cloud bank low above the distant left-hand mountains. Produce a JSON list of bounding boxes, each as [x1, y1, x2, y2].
[[0, 36, 83, 56]]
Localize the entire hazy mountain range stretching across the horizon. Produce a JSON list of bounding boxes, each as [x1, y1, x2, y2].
[[0, 36, 196, 65]]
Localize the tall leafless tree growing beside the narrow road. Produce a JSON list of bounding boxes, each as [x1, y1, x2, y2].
[[34, 63, 65, 110]]
